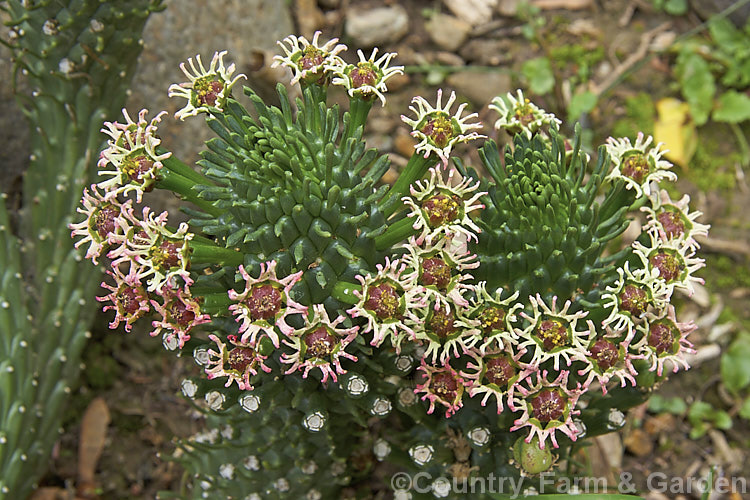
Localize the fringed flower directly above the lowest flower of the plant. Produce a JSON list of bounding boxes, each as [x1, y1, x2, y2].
[[516, 294, 596, 371]]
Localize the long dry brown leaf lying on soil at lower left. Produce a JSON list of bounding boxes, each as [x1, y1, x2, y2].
[[78, 398, 110, 491]]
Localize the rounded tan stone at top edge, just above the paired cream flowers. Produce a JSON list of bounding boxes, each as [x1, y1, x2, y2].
[[346, 5, 409, 47]]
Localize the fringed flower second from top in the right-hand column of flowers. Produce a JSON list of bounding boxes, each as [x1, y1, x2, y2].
[[641, 189, 710, 248]]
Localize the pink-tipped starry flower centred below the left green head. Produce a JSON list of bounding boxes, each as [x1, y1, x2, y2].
[[281, 304, 359, 383]]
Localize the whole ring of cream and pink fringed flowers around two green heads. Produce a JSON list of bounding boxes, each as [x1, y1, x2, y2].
[[70, 29, 707, 456]]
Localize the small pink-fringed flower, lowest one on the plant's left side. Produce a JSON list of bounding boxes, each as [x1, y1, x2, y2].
[[206, 334, 271, 391]]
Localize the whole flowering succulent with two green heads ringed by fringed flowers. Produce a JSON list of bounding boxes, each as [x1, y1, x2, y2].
[[73, 34, 707, 499]]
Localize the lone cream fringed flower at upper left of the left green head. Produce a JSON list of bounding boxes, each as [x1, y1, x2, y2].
[[169, 50, 247, 120]]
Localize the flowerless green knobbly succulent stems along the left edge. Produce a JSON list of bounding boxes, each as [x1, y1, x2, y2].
[[0, 0, 161, 498]]
